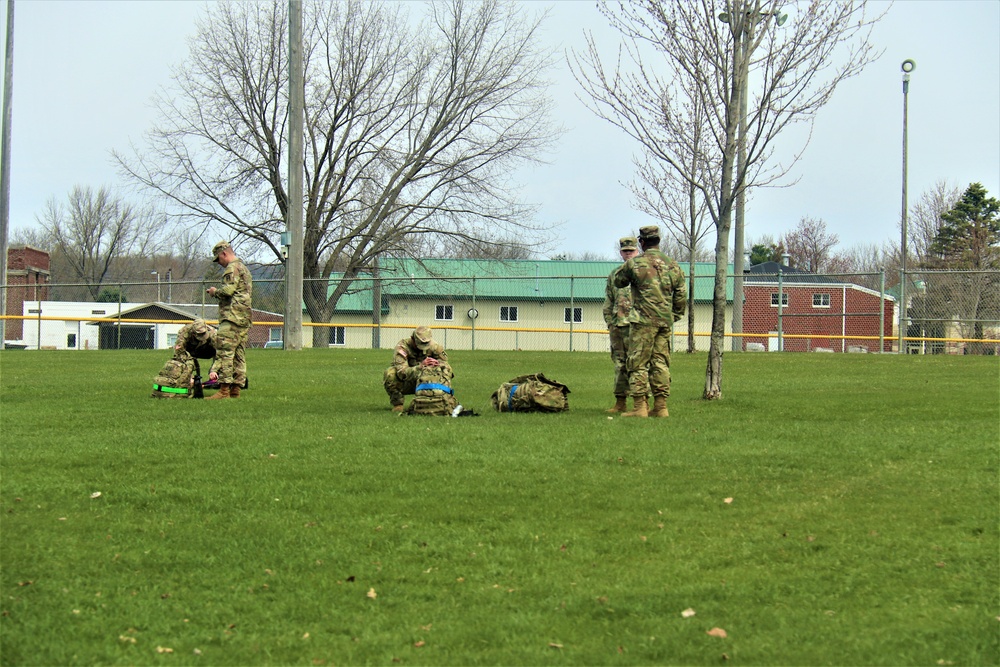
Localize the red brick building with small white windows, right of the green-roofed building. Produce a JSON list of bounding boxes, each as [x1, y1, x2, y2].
[[742, 262, 896, 352]]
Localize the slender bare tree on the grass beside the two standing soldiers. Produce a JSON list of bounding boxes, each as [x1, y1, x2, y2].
[[570, 0, 875, 399]]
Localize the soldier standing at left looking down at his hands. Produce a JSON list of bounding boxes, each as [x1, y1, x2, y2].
[[206, 241, 253, 400]]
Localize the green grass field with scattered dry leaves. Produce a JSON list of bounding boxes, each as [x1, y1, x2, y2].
[[0, 350, 1000, 665]]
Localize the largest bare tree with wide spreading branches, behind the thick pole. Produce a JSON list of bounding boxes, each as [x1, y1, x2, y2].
[[118, 0, 555, 345]]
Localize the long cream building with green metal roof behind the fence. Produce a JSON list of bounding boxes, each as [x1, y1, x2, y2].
[[306, 259, 733, 351]]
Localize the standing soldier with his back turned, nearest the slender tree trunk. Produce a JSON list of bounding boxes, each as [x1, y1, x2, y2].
[[614, 225, 687, 417]]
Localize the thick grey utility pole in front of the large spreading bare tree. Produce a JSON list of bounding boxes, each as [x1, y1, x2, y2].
[[282, 0, 305, 350]]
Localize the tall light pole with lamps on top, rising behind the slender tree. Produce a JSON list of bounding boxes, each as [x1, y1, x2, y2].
[[719, 11, 788, 351]]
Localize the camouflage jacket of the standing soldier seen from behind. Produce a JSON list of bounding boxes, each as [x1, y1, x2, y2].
[[614, 248, 687, 326]]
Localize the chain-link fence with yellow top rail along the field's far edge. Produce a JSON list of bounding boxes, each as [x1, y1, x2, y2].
[[4, 270, 1000, 354]]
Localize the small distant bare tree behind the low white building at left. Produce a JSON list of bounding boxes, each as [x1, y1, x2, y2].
[[36, 186, 163, 299]]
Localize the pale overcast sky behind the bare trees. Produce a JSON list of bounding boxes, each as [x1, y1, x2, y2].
[[0, 0, 1000, 258]]
